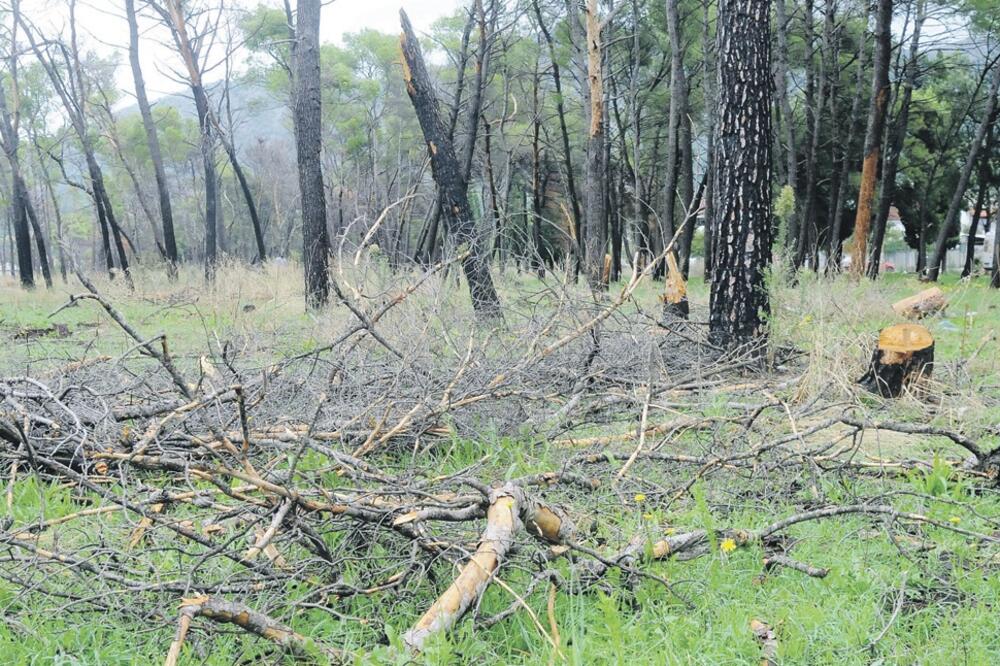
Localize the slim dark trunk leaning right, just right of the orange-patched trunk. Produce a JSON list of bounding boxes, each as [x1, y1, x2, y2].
[[868, 0, 927, 280]]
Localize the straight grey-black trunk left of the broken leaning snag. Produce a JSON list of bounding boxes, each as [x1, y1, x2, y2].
[[295, 0, 330, 308]]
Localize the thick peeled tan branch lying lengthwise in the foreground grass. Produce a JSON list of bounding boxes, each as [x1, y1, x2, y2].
[[403, 484, 524, 652]]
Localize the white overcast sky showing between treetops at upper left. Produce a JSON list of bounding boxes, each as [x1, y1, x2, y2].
[[29, 0, 461, 103]]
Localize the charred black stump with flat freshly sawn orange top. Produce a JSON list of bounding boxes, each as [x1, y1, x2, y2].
[[858, 324, 934, 398]]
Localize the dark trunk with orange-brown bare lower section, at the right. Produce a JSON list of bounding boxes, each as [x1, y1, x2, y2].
[[851, 0, 892, 277]]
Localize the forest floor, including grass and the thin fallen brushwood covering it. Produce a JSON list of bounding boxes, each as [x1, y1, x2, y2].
[[0, 266, 1000, 664]]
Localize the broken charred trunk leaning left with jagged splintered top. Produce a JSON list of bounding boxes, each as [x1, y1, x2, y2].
[[399, 10, 501, 317]]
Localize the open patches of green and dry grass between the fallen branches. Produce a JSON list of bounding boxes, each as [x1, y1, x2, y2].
[[0, 267, 1000, 664]]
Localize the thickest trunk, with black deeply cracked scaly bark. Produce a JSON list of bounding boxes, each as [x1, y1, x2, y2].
[[709, 0, 772, 349]]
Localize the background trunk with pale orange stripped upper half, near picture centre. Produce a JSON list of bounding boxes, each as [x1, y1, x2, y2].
[[583, 0, 607, 292]]
